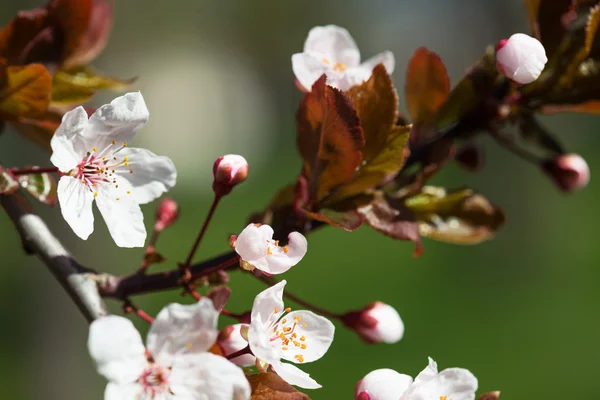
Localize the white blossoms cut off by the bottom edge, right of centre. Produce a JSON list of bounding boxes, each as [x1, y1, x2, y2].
[[355, 358, 477, 400]]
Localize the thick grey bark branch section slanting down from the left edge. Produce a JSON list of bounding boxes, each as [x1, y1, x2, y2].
[[0, 192, 108, 322]]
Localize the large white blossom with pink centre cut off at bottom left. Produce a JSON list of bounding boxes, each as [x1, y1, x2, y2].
[[88, 298, 250, 400]]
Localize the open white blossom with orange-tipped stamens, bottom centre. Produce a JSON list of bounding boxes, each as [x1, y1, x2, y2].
[[248, 281, 335, 389]]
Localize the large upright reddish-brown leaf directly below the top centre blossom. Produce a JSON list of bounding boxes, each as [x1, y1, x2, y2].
[[296, 75, 365, 202]]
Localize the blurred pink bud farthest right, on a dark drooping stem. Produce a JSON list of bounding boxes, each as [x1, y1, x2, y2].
[[541, 154, 590, 192]]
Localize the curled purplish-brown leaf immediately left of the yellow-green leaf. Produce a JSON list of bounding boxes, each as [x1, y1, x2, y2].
[[360, 198, 423, 257]]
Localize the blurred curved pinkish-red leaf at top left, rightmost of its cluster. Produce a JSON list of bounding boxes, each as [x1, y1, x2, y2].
[[63, 0, 113, 69]]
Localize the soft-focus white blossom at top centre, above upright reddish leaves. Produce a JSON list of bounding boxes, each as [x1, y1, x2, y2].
[[292, 25, 395, 92]]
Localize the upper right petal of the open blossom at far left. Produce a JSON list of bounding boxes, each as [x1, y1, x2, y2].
[[83, 92, 150, 150]]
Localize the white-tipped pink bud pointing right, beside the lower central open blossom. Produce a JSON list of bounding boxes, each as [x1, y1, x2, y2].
[[343, 301, 404, 343]]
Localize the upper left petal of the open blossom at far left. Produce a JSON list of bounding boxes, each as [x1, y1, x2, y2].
[[50, 107, 88, 173]]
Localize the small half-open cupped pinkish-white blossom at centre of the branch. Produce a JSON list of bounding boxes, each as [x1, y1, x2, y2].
[[235, 224, 308, 275]]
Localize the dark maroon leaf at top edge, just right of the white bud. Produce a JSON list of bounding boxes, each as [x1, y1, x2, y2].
[[538, 0, 572, 59]]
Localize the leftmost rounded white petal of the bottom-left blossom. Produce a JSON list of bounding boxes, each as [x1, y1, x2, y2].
[[88, 315, 147, 384]]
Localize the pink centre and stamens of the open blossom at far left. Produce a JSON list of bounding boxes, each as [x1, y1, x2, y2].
[[68, 140, 133, 200]]
